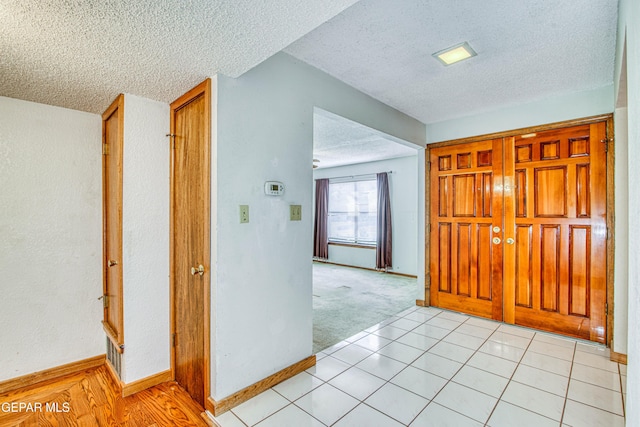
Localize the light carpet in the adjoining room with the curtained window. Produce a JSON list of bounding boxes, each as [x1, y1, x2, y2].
[[313, 262, 416, 353]]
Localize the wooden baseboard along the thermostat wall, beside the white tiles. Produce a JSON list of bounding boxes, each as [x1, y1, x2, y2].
[[204, 355, 316, 416]]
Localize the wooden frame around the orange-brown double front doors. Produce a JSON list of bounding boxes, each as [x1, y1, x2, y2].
[[424, 113, 615, 347]]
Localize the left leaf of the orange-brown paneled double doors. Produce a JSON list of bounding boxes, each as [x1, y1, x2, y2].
[[430, 140, 502, 319]]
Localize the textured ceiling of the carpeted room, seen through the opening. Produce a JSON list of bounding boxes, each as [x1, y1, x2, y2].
[[313, 108, 417, 168]]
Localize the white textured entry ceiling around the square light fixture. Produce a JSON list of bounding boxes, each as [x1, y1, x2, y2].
[[285, 0, 618, 123]]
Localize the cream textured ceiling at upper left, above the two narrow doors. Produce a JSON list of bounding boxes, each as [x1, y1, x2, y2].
[[0, 0, 356, 113]]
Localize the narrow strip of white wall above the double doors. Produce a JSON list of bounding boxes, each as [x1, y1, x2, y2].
[[427, 85, 614, 143]]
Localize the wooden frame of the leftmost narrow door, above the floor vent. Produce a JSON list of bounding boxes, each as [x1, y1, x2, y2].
[[102, 93, 124, 353]]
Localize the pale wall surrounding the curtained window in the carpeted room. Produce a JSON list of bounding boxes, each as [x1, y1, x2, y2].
[[311, 154, 418, 276]]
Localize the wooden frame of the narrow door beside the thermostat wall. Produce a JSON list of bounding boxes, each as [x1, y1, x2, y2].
[[169, 79, 212, 402]]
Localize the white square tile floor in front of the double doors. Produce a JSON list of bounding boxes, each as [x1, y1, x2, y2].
[[216, 307, 626, 427]]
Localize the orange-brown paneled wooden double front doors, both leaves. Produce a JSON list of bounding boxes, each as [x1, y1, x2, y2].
[[429, 122, 607, 343]]
